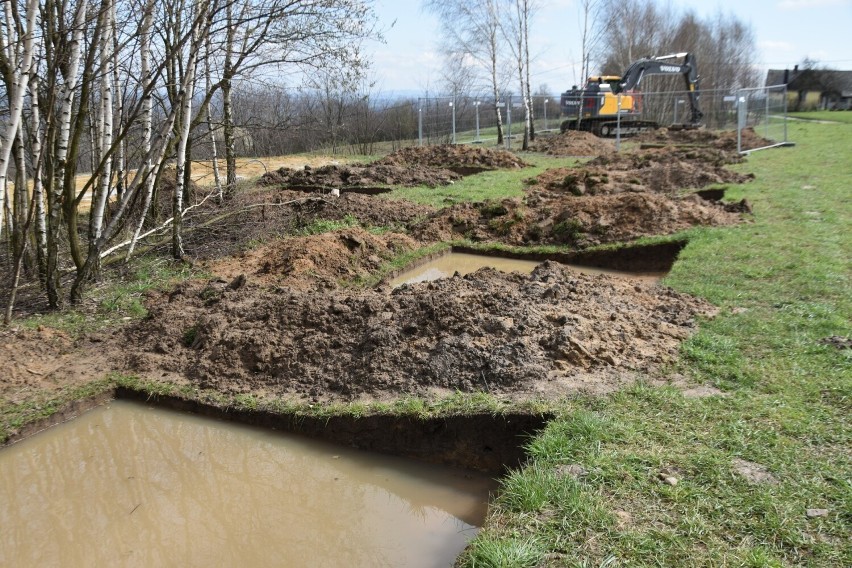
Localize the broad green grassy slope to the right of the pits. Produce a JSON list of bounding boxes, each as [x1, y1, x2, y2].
[[462, 118, 852, 566]]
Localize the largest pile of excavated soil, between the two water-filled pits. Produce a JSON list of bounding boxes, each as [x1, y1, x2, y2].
[[122, 263, 713, 400]]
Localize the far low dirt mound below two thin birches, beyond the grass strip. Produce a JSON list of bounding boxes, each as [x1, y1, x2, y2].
[[376, 144, 529, 169]]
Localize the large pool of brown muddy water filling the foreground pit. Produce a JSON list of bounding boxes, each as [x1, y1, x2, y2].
[[0, 401, 494, 566]]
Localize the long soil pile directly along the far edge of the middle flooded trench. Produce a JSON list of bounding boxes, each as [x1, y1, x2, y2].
[[412, 192, 748, 248]]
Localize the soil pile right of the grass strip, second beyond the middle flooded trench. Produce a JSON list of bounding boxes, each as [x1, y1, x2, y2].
[[528, 148, 753, 196]]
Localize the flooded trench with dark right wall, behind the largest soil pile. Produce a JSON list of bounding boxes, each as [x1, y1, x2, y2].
[[384, 241, 686, 287]]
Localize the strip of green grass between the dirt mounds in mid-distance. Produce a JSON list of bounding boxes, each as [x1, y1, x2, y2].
[[381, 153, 577, 207]]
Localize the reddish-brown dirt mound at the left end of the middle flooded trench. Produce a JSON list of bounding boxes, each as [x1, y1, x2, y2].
[[205, 227, 418, 288]]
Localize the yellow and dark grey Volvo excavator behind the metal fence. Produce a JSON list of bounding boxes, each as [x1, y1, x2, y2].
[[560, 53, 703, 136]]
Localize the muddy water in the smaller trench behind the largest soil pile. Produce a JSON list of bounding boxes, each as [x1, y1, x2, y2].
[[390, 252, 665, 287]]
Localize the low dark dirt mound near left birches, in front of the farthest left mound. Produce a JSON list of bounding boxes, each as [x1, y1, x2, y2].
[[257, 163, 461, 189]]
